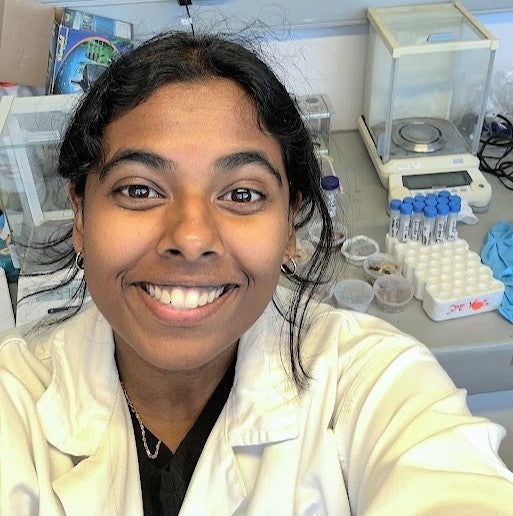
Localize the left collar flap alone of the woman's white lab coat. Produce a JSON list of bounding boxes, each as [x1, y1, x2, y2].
[[37, 304, 119, 457]]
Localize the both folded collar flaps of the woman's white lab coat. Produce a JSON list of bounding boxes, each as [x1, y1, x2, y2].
[[38, 296, 299, 457]]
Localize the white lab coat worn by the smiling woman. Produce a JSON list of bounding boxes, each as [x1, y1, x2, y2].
[[0, 292, 513, 516]]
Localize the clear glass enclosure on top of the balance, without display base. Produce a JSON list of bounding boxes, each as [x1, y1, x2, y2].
[[362, 2, 498, 163]]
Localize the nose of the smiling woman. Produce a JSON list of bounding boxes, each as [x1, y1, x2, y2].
[[158, 197, 223, 262]]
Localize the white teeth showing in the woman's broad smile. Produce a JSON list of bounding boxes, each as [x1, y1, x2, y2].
[[145, 283, 228, 310]]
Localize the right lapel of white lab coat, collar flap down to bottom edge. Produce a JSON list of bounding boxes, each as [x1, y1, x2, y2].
[[180, 296, 299, 516]]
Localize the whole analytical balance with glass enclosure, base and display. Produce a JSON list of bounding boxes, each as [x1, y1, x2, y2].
[[358, 2, 498, 211]]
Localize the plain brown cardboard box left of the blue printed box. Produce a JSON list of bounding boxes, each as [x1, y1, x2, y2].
[[0, 0, 55, 87]]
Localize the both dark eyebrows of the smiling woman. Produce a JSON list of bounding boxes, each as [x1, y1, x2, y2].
[[99, 149, 283, 186]]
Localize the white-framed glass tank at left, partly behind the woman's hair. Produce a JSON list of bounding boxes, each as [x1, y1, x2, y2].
[[0, 95, 78, 273]]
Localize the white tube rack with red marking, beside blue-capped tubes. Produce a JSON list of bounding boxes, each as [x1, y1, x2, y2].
[[385, 235, 504, 321]]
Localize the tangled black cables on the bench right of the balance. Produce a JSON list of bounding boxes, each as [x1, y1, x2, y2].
[[477, 115, 513, 190]]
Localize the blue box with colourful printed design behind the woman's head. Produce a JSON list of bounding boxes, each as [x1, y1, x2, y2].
[[47, 8, 133, 94]]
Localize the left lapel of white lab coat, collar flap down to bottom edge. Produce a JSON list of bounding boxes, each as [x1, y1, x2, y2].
[[37, 305, 142, 516]]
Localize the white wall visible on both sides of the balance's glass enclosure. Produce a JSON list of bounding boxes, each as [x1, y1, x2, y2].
[[268, 12, 513, 130]]
